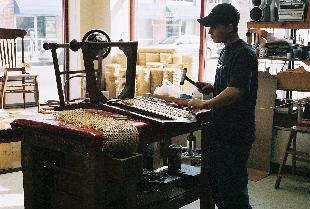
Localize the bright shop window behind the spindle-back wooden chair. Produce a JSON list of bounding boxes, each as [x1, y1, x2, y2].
[[0, 0, 63, 103]]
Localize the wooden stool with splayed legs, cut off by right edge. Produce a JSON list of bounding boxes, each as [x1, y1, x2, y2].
[[275, 126, 310, 189]]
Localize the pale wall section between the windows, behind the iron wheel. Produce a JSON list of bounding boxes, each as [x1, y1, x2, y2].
[[69, 0, 129, 99]]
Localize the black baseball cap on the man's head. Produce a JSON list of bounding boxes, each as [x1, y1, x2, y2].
[[197, 3, 240, 27]]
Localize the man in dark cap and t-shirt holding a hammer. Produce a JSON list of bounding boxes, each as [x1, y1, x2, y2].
[[188, 4, 258, 209]]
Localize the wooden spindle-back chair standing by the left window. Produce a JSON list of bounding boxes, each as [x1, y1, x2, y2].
[[0, 28, 40, 111]]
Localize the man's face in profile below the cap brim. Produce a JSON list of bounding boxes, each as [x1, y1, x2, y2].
[[209, 24, 232, 43]]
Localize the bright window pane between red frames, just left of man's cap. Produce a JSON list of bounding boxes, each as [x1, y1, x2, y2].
[[136, 0, 201, 82]]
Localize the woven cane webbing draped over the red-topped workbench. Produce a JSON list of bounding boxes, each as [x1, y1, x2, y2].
[[55, 109, 139, 153]]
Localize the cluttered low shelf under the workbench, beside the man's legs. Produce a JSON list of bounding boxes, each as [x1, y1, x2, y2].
[[137, 164, 201, 209]]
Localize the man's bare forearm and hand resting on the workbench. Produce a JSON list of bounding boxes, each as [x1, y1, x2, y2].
[[188, 87, 244, 109]]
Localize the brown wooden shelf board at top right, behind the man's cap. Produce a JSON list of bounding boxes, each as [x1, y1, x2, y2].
[[247, 22, 310, 29]]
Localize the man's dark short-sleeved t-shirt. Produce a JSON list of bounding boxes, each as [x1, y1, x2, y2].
[[211, 39, 258, 145]]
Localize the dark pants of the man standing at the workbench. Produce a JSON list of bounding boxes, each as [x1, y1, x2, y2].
[[207, 145, 252, 209]]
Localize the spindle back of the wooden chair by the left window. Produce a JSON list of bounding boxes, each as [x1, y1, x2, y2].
[[0, 28, 27, 68]]
